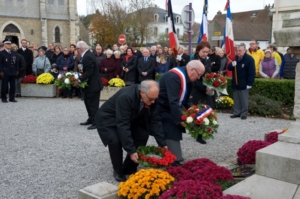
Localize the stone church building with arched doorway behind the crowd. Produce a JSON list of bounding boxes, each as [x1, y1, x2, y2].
[[0, 0, 80, 46]]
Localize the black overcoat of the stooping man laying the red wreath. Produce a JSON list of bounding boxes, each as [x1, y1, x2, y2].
[[95, 85, 166, 154]]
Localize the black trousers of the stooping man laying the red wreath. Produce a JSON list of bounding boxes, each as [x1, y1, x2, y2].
[[108, 126, 149, 175]]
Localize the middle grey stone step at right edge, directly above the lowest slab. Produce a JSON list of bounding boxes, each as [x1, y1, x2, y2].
[[255, 142, 300, 184]]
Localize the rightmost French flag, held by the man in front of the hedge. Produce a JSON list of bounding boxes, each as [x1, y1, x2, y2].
[[222, 0, 235, 77]]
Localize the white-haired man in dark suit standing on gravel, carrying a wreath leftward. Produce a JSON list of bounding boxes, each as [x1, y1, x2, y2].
[[73, 41, 103, 130]]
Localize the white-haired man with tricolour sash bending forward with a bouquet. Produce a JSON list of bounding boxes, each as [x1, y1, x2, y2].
[[157, 60, 205, 165]]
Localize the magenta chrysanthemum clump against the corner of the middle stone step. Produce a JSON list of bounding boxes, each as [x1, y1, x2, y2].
[[237, 140, 271, 164]]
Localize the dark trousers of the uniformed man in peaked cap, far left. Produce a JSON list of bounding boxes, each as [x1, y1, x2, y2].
[[1, 76, 16, 100]]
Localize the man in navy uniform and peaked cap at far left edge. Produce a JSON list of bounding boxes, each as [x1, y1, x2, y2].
[[0, 39, 19, 103]]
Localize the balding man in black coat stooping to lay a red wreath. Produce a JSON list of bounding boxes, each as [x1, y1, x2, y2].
[[96, 80, 166, 181]]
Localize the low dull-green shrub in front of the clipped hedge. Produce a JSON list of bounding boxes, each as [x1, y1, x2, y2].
[[249, 94, 282, 116]]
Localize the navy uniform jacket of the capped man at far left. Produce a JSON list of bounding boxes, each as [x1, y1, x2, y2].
[[0, 49, 19, 76]]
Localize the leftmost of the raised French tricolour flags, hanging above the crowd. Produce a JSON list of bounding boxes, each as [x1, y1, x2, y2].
[[167, 0, 179, 57]]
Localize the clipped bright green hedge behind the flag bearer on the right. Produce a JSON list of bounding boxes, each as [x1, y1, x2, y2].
[[227, 78, 295, 105]]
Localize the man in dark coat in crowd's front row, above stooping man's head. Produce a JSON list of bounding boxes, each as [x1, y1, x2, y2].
[[137, 48, 155, 82]]
